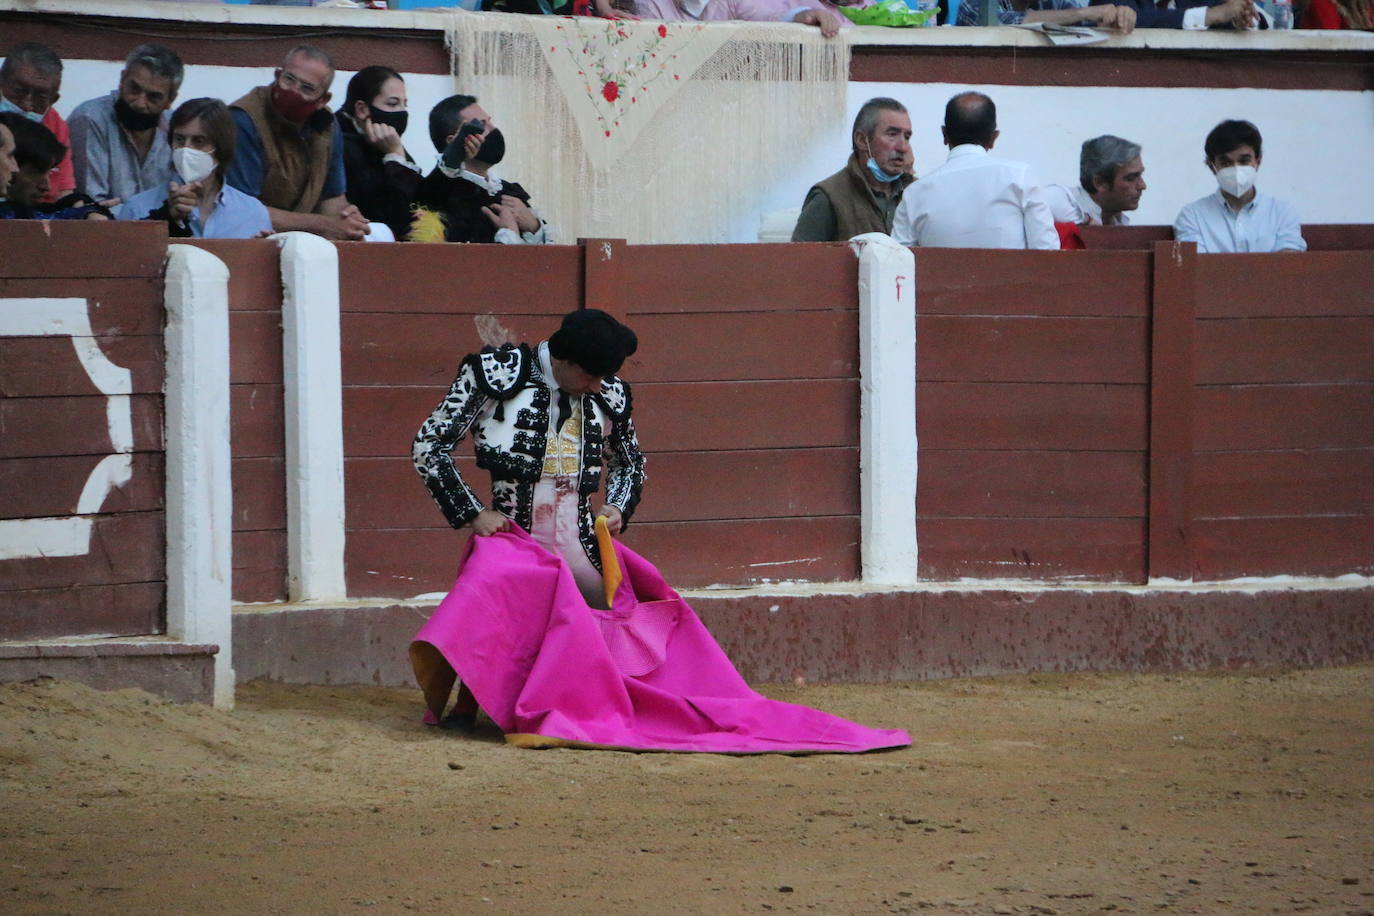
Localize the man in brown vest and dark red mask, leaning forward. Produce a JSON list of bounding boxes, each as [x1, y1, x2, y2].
[[224, 44, 367, 239]]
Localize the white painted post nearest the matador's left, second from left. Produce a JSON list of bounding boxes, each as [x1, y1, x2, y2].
[[272, 232, 348, 602]]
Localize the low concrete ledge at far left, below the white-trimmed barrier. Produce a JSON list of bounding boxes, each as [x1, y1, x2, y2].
[[0, 640, 220, 703]]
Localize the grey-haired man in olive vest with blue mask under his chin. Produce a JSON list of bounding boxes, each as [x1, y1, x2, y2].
[[791, 98, 915, 242]]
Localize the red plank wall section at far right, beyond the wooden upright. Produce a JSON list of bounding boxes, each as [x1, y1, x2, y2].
[[1193, 251, 1374, 580]]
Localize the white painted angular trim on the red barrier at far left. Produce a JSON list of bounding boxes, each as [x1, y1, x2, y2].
[[0, 297, 133, 560]]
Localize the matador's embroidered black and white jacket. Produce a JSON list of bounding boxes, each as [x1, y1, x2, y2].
[[411, 343, 644, 569]]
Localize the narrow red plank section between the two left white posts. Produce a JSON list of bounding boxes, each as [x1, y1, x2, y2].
[[186, 239, 286, 602]]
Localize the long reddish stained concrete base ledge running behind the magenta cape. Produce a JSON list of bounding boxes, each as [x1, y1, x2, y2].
[[234, 582, 1374, 687]]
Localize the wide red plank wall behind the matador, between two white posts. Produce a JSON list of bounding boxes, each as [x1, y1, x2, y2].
[[341, 242, 859, 596]]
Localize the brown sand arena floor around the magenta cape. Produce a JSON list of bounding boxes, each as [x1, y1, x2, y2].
[[0, 666, 1374, 915]]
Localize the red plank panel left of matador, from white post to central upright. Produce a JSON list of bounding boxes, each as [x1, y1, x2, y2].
[[339, 243, 585, 597]]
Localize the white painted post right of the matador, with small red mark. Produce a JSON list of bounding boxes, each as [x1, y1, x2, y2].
[[851, 232, 916, 585]]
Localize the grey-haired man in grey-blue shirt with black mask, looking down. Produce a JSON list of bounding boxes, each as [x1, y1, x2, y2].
[[69, 44, 183, 206]]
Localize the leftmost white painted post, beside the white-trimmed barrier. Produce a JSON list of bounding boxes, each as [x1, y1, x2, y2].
[[164, 244, 234, 709]]
